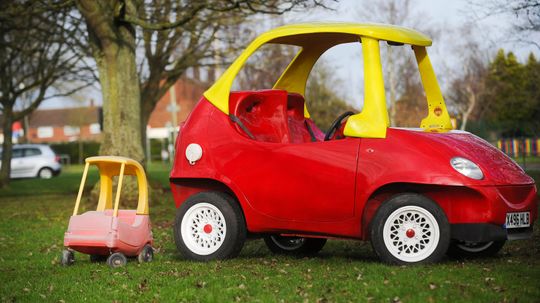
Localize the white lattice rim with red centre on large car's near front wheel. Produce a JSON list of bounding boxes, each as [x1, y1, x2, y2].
[[383, 206, 440, 262]]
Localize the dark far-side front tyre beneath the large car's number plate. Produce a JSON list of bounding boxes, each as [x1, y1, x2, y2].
[[446, 240, 506, 259]]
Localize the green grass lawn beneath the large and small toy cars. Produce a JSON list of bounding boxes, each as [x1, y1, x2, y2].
[[0, 164, 540, 302]]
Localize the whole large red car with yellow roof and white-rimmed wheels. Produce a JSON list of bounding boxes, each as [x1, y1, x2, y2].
[[170, 23, 538, 264]]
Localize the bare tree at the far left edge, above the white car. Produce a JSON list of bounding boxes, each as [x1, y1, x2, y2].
[[0, 1, 87, 187]]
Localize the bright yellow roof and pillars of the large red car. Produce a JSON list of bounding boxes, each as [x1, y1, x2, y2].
[[204, 22, 452, 138]]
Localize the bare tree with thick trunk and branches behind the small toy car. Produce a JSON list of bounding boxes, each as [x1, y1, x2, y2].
[[76, 0, 334, 166]]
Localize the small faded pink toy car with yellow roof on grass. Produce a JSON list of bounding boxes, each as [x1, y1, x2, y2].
[[61, 156, 154, 267]]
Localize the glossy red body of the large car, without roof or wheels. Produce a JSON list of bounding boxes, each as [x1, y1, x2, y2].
[[170, 90, 538, 242]]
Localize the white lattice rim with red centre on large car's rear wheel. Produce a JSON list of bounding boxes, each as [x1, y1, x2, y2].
[[181, 203, 227, 256]]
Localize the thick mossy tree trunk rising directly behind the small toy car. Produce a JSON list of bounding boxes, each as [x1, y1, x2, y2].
[[78, 0, 144, 162]]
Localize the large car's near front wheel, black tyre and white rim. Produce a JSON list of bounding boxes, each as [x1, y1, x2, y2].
[[370, 194, 450, 264]]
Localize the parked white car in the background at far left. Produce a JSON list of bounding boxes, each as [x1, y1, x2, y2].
[[0, 144, 62, 179]]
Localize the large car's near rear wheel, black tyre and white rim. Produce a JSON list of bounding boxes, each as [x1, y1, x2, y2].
[[174, 192, 246, 261]]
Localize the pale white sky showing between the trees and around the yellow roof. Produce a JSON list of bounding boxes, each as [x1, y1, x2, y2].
[[41, 0, 540, 108]]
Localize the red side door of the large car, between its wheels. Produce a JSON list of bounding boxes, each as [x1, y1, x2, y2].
[[228, 138, 359, 222]]
